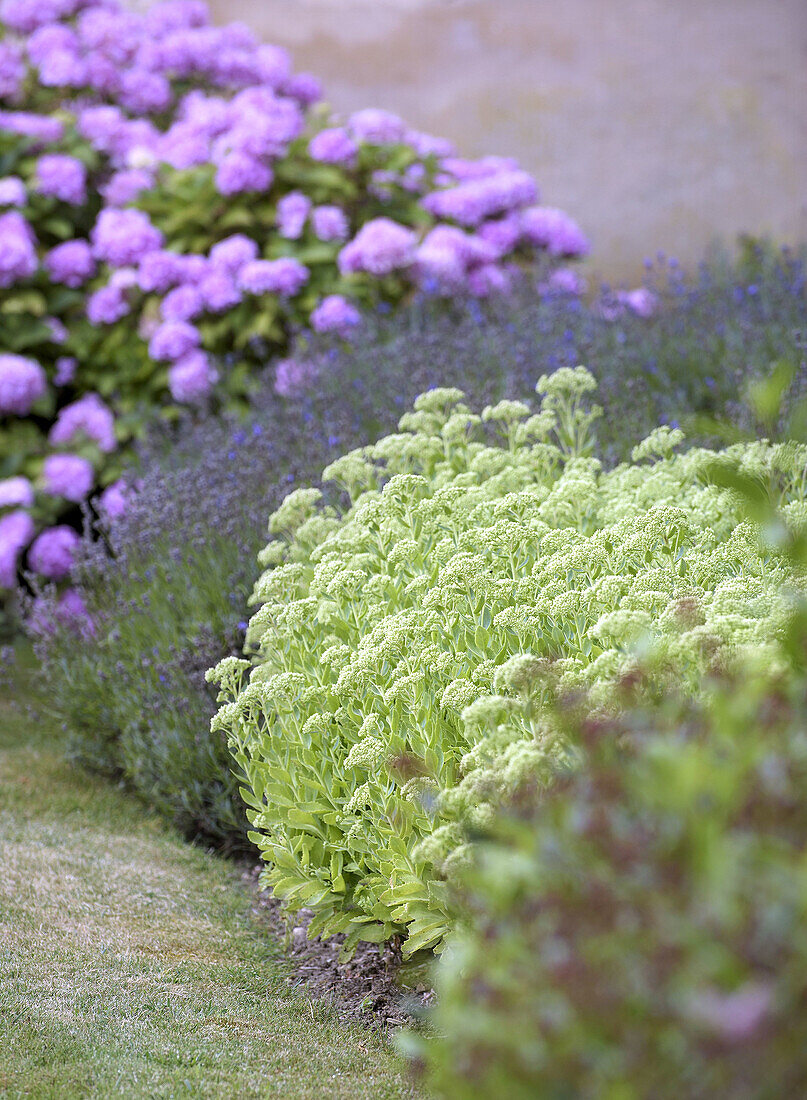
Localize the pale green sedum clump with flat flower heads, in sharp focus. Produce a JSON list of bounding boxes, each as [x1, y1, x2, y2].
[[208, 367, 807, 955]]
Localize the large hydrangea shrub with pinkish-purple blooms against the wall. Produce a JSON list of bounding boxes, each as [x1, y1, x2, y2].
[[0, 0, 587, 594]]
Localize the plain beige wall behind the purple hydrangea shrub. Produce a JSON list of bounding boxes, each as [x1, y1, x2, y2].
[[212, 0, 807, 276]]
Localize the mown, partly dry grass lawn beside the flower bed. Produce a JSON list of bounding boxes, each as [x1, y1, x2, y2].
[[0, 655, 413, 1100]]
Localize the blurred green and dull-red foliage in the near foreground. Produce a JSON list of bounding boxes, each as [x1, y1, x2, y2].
[[419, 616, 807, 1100]]
